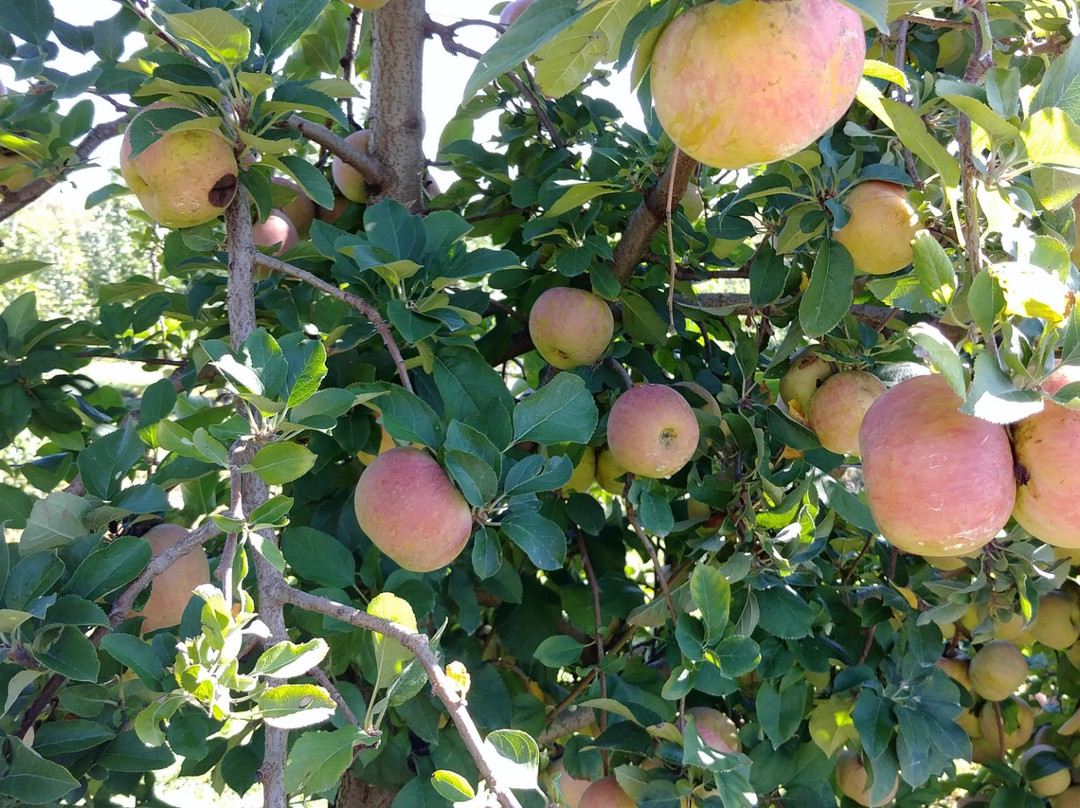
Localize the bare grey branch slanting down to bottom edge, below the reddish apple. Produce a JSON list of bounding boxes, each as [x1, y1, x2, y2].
[[270, 575, 521, 808]]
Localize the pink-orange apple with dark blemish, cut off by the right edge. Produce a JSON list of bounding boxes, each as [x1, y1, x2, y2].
[[1013, 365, 1080, 549]]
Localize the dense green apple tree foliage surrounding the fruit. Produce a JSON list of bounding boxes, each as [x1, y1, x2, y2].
[[0, 0, 1080, 808]]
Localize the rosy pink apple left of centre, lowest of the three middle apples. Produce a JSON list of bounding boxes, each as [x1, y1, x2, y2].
[[354, 447, 473, 573]]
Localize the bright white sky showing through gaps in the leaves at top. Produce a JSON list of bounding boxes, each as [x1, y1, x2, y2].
[[19, 0, 642, 205]]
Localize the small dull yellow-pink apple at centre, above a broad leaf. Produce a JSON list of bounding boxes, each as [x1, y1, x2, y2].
[[529, 286, 615, 371]]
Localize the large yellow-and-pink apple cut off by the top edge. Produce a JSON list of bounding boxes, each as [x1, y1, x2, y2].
[[652, 0, 866, 169]]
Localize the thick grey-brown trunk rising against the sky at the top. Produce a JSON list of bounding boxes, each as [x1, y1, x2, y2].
[[370, 0, 427, 213]]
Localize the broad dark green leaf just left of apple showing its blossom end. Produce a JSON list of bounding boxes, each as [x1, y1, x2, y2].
[[514, 373, 599, 446]]
